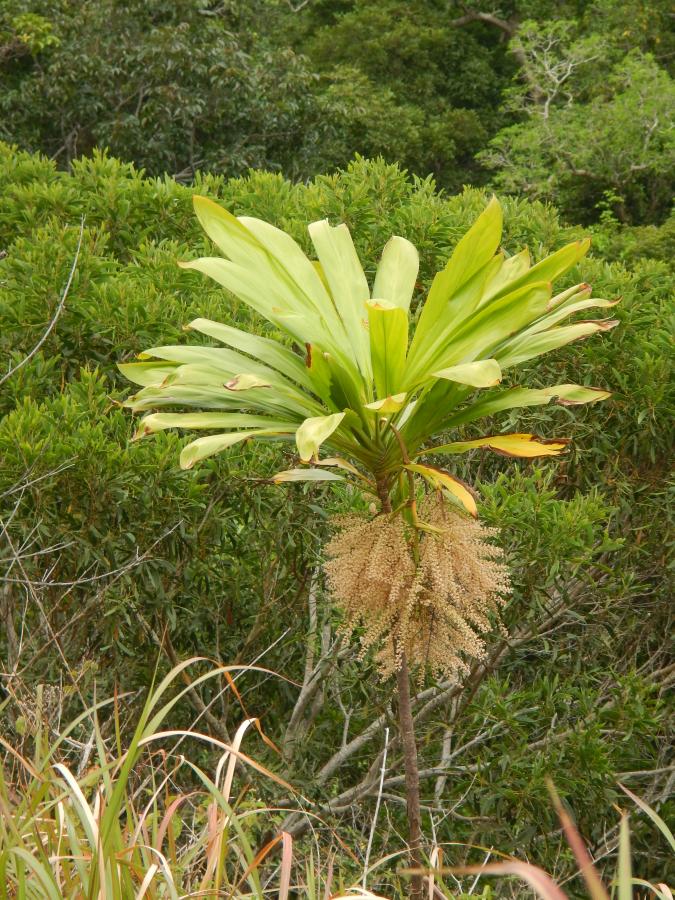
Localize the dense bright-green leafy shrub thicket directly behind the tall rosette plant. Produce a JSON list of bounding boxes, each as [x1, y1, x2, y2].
[[0, 145, 672, 875]]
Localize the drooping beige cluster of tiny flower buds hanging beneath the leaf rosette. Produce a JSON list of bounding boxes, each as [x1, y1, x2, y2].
[[325, 494, 510, 678]]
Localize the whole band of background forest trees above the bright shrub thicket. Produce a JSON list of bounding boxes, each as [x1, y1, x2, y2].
[[0, 0, 675, 225]]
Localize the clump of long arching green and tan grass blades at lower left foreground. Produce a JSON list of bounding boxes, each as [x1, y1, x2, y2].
[[0, 660, 338, 900]]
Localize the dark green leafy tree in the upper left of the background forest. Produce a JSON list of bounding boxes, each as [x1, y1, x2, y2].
[[0, 0, 336, 178]]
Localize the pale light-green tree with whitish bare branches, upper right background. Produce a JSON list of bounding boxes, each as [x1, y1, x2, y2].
[[481, 49, 675, 223]]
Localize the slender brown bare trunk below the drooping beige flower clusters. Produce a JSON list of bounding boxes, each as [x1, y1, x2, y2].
[[396, 653, 423, 900]]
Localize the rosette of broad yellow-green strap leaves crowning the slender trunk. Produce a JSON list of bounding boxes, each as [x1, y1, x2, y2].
[[120, 197, 616, 515]]
